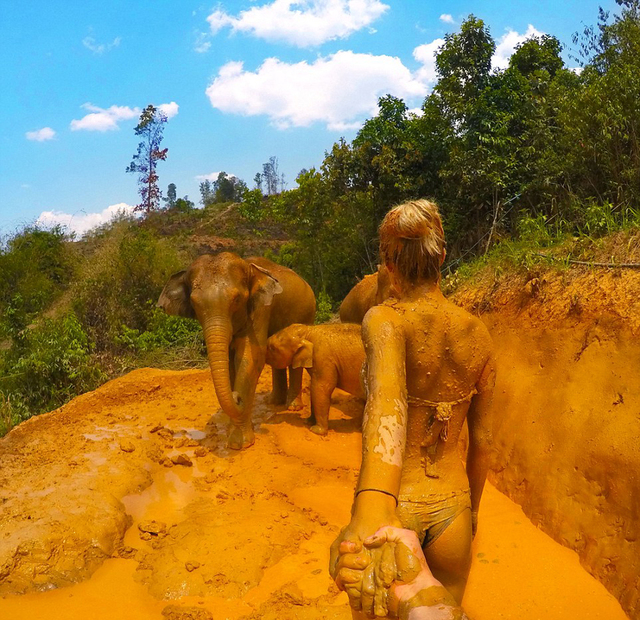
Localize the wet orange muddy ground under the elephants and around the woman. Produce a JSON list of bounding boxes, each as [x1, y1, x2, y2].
[[0, 369, 626, 620]]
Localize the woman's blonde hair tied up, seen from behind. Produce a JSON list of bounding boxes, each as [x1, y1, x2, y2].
[[380, 199, 445, 282]]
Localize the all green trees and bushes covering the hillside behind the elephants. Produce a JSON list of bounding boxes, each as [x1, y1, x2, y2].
[[0, 0, 640, 434]]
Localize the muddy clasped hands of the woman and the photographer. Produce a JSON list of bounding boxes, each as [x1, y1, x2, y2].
[[331, 526, 441, 618]]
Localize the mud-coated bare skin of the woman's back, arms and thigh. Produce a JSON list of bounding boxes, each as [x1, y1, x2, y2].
[[334, 282, 495, 612]]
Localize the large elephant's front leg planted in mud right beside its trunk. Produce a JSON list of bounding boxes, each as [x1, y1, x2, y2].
[[228, 338, 265, 450]]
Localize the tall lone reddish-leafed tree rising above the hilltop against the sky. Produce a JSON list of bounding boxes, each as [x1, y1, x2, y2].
[[127, 104, 169, 213]]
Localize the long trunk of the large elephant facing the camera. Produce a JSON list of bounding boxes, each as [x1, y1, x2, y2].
[[203, 319, 244, 424]]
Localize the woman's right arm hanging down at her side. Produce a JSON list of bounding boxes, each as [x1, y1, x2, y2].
[[467, 350, 496, 536]]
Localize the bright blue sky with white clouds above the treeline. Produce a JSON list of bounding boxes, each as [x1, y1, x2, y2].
[[0, 0, 615, 234]]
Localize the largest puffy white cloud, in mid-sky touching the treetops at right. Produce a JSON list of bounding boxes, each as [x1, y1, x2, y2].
[[206, 51, 427, 131]]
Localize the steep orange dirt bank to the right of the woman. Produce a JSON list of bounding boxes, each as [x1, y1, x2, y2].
[[455, 269, 640, 618]]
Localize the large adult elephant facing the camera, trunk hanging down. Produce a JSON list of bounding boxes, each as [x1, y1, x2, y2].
[[158, 252, 316, 450]]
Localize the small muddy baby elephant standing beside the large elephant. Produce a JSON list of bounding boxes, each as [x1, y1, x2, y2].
[[266, 323, 365, 435]]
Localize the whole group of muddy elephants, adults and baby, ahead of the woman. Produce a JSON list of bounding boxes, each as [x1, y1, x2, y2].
[[158, 252, 391, 450]]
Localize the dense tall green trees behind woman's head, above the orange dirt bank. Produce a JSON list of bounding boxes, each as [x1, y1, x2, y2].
[[243, 0, 640, 300]]
